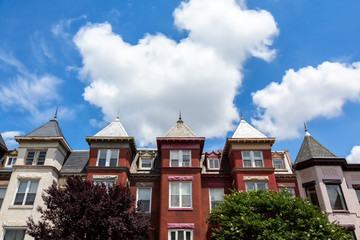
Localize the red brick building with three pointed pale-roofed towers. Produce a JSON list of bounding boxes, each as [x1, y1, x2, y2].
[[85, 117, 299, 240]]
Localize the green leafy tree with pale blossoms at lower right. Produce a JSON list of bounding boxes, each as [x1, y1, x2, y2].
[[208, 190, 351, 240]]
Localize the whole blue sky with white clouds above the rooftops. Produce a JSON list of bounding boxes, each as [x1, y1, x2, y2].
[[0, 0, 360, 162]]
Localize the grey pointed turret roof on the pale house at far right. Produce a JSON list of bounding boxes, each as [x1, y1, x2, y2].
[[295, 131, 336, 164]]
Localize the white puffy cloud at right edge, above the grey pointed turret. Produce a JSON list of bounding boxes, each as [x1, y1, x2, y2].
[[252, 62, 360, 140]]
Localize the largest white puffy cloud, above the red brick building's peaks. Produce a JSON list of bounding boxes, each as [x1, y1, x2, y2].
[[74, 0, 278, 146]]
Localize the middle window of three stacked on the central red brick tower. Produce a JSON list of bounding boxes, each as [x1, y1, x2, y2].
[[170, 182, 192, 208]]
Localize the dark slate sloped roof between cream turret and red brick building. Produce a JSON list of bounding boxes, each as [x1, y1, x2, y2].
[[60, 150, 89, 173]]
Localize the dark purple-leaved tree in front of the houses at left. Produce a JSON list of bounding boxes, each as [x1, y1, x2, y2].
[[27, 177, 150, 240]]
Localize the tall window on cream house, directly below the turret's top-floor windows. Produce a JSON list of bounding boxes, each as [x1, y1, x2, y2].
[[14, 181, 39, 205]]
